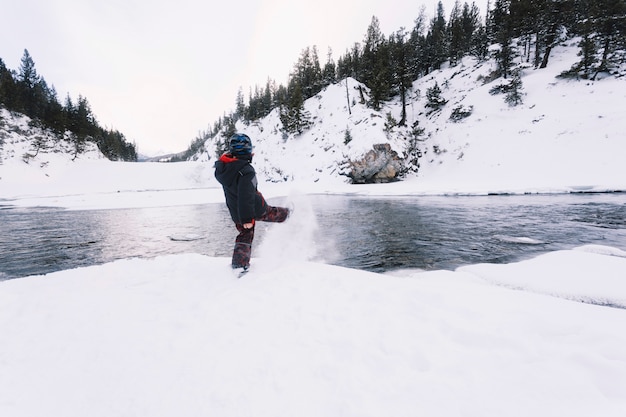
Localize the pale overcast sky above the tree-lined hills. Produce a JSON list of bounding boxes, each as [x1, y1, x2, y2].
[[0, 0, 464, 155]]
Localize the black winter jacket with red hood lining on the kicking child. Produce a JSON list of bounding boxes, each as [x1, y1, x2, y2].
[[215, 154, 267, 224]]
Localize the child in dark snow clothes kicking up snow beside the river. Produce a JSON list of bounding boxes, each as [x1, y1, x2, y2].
[[215, 133, 289, 272]]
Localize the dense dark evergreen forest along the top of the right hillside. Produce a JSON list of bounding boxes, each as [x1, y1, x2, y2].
[[179, 0, 626, 160]]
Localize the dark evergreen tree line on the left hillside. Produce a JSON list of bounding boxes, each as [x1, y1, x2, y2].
[[0, 49, 137, 161]]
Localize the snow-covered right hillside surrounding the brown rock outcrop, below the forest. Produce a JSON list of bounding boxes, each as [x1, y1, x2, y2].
[[191, 40, 626, 193]]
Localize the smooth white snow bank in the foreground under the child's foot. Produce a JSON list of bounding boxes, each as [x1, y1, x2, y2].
[[0, 248, 626, 417]]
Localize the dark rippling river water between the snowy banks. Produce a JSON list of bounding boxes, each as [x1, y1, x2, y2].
[[0, 193, 626, 279]]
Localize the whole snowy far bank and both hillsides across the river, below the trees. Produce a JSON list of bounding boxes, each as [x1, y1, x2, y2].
[[0, 40, 626, 198]]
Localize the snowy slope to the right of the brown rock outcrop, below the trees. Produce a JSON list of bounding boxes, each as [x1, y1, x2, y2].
[[410, 42, 626, 192]]
